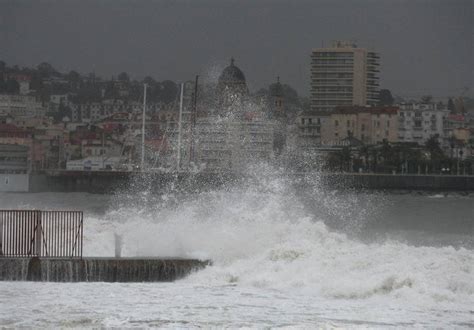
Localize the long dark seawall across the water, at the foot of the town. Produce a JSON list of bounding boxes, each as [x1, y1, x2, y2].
[[22, 171, 474, 193]]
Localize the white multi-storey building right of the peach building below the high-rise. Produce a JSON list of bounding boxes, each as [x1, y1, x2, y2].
[[398, 103, 449, 145]]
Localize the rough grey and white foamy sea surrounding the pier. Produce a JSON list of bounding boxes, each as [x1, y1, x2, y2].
[[0, 171, 474, 328]]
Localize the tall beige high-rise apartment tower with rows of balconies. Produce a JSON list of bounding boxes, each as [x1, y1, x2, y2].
[[311, 41, 380, 111]]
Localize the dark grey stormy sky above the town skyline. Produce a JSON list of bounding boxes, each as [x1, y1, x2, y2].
[[0, 0, 474, 97]]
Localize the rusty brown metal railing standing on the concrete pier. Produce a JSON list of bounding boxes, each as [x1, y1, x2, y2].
[[0, 210, 83, 258]]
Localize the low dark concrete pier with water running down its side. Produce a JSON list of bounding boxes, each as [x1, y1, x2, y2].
[[0, 258, 210, 282]]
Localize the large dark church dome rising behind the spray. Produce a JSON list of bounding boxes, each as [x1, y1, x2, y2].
[[217, 58, 249, 110]]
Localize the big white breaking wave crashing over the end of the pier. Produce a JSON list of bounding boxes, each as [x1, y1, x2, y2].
[[79, 168, 474, 306]]
